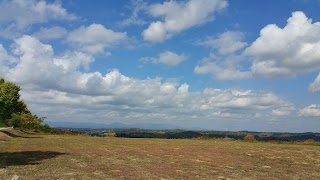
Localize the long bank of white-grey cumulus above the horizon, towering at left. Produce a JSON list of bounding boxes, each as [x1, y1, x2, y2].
[[0, 36, 292, 122]]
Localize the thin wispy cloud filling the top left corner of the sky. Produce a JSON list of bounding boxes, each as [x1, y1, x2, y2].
[[0, 0, 77, 38]]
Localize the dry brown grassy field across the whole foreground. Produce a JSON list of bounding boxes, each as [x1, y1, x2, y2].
[[0, 130, 320, 179]]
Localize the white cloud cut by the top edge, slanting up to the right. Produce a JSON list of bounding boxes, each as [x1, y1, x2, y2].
[[142, 0, 228, 42]]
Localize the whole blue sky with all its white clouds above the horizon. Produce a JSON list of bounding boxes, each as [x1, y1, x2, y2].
[[0, 0, 320, 132]]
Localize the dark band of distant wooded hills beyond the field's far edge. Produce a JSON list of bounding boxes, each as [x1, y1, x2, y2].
[[83, 128, 320, 142]]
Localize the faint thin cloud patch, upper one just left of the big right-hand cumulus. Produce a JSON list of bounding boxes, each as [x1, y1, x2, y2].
[[199, 31, 248, 54]]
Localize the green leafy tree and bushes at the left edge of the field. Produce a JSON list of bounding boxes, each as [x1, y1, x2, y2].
[[0, 78, 50, 130]]
